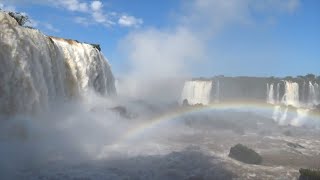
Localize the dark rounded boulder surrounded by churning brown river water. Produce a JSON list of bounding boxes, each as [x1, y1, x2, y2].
[[229, 144, 262, 164]]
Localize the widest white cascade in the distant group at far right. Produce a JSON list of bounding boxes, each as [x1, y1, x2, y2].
[[282, 81, 300, 107]]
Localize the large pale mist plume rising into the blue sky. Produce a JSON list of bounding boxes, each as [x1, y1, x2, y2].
[[119, 0, 299, 100]]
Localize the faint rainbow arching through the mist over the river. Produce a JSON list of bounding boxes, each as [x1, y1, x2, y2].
[[120, 101, 320, 142]]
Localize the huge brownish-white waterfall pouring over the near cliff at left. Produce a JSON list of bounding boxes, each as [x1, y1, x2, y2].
[[0, 13, 115, 114]]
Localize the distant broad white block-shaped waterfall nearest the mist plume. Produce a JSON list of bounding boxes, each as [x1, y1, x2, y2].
[[181, 81, 212, 105]]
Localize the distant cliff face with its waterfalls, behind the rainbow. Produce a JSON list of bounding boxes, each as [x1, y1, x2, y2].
[[180, 75, 320, 108]]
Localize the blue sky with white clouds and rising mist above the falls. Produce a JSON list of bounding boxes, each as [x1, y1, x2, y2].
[[0, 0, 320, 77]]
